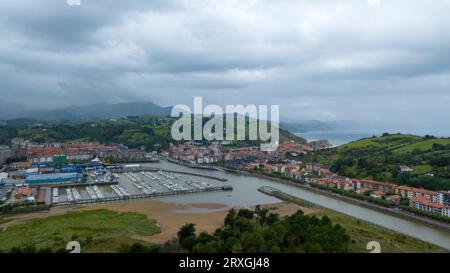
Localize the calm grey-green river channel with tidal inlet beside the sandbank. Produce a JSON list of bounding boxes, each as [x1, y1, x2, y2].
[[142, 161, 450, 250]]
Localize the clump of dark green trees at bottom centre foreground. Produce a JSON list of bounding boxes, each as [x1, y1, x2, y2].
[[178, 206, 350, 253]]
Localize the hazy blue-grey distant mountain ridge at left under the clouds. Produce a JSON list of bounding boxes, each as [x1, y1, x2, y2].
[[0, 102, 172, 121]]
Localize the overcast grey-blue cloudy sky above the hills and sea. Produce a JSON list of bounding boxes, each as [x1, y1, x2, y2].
[[0, 0, 450, 128]]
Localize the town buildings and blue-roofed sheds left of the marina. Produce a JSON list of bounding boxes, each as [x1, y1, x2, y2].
[[0, 138, 154, 205]]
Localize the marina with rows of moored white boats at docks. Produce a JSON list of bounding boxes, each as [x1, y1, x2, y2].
[[51, 165, 232, 206]]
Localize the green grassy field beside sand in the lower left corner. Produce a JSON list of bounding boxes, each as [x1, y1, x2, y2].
[[0, 209, 160, 252]]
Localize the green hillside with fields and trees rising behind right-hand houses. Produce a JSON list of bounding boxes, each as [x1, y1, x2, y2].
[[301, 134, 450, 190]]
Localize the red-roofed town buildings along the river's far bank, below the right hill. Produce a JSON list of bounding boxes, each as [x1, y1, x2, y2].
[[164, 141, 450, 217]]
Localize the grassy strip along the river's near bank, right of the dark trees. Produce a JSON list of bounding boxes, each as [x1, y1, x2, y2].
[[277, 192, 446, 253]]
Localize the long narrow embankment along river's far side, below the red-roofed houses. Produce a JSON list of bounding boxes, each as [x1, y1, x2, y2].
[[217, 167, 450, 231]]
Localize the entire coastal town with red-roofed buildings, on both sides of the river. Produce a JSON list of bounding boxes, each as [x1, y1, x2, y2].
[[0, 138, 450, 223]]
